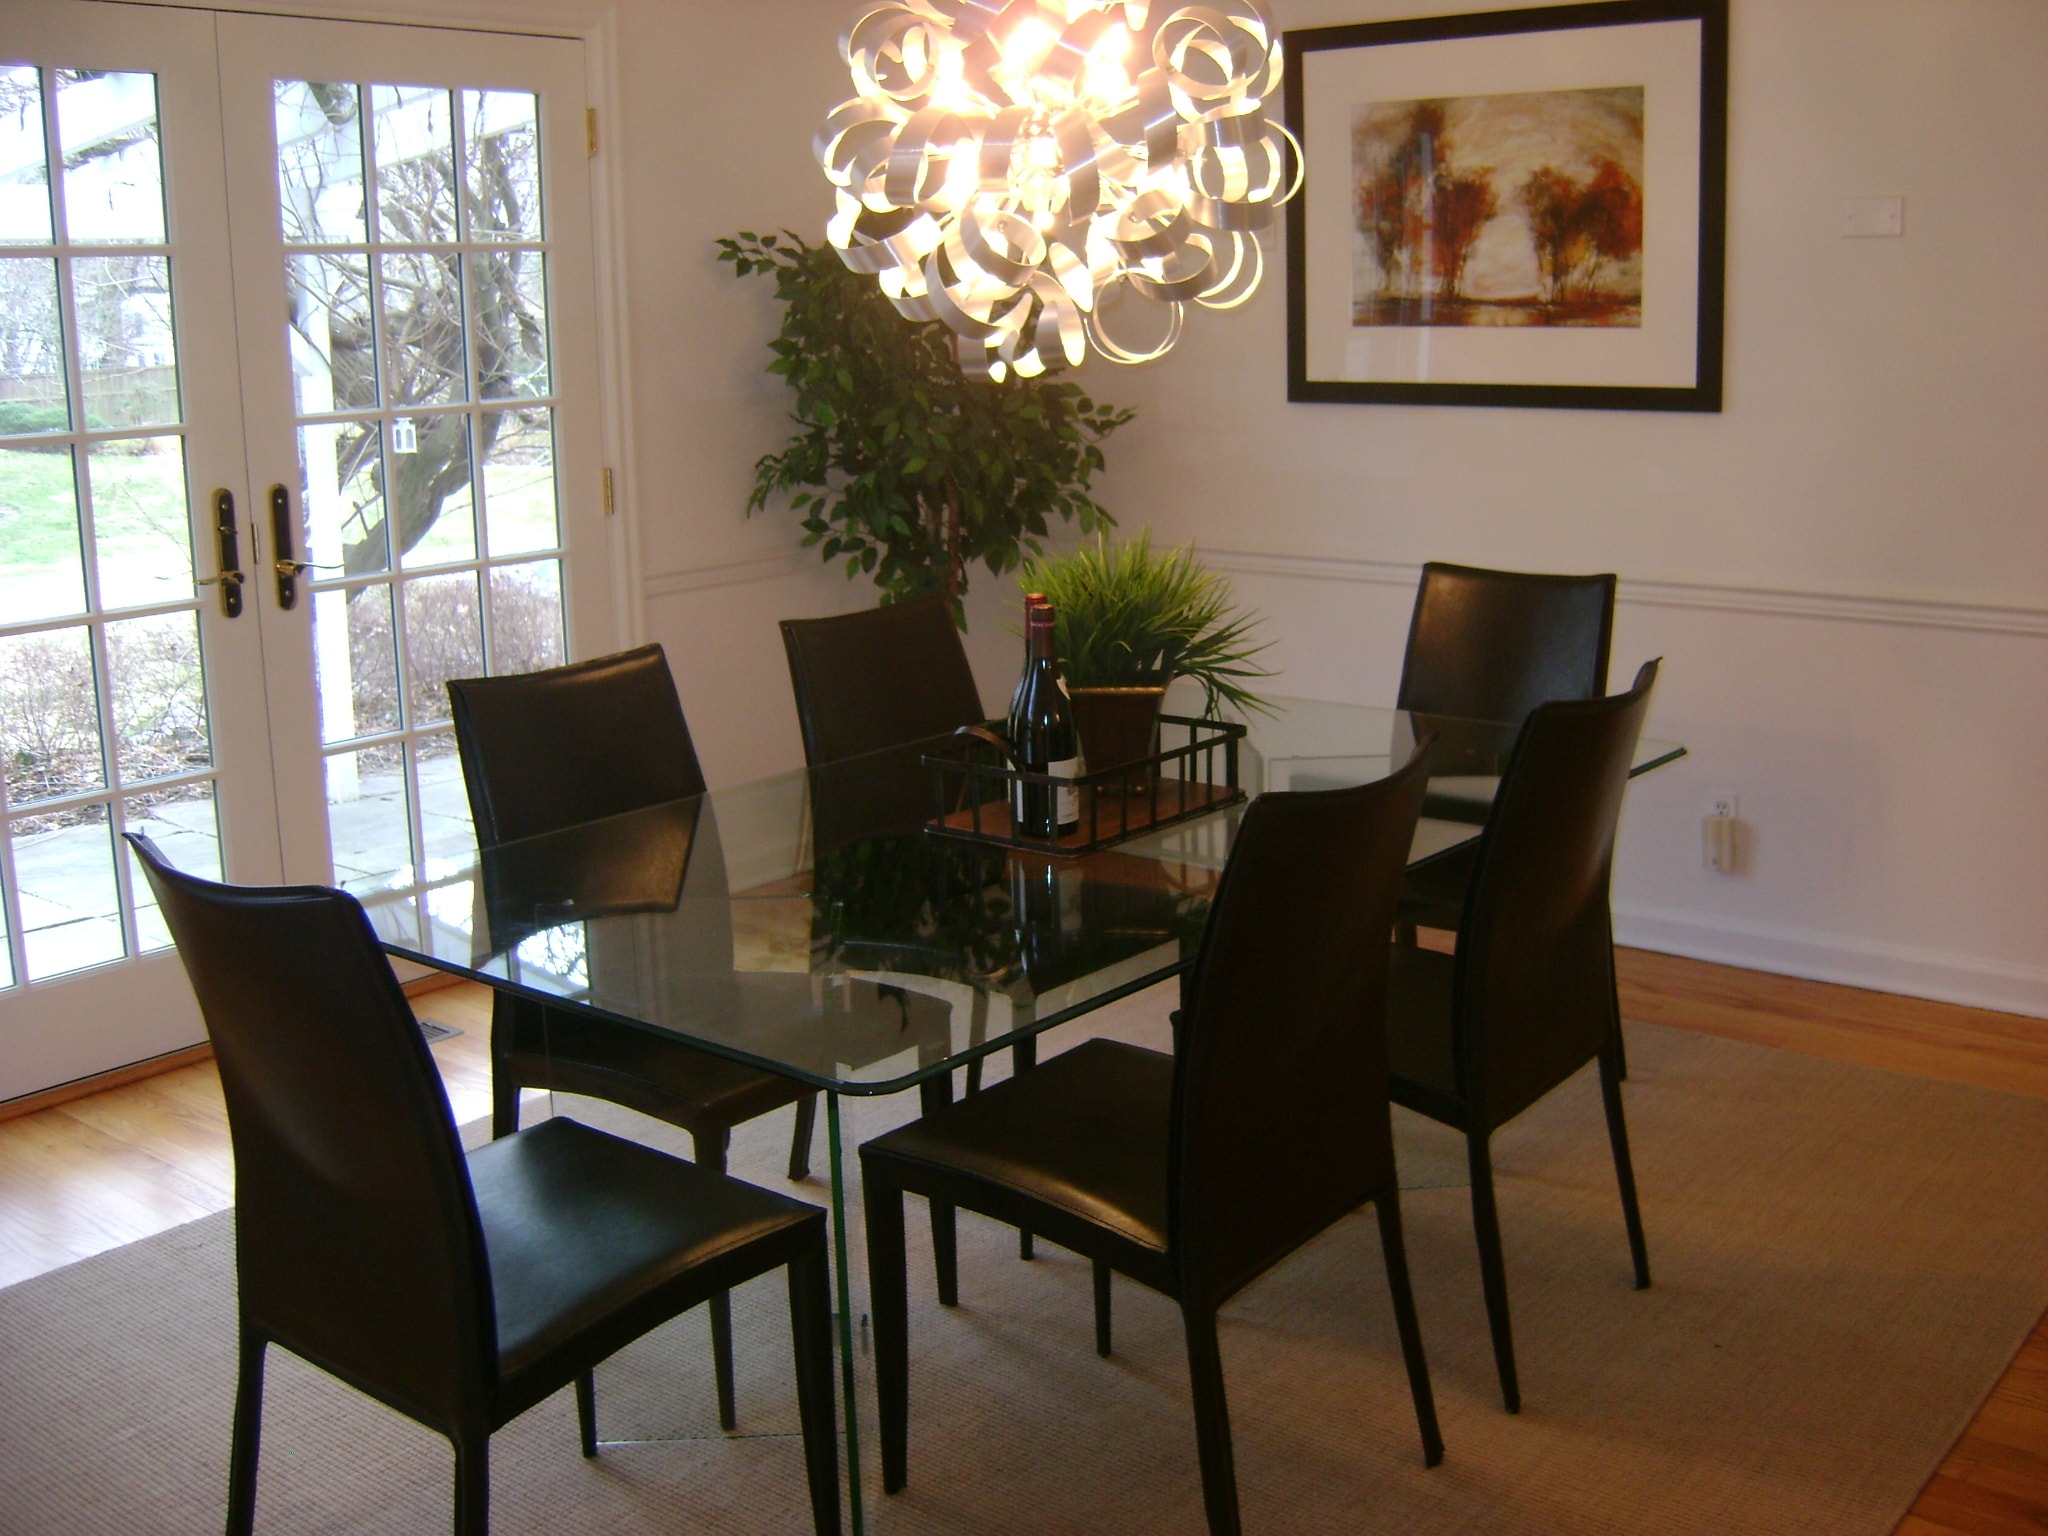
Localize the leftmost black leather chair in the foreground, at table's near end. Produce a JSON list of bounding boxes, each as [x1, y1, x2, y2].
[[129, 834, 840, 1536]]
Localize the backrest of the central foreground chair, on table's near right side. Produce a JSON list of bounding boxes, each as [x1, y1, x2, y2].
[[1169, 743, 1430, 1303]]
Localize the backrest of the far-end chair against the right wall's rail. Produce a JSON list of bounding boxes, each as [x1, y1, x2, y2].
[[1397, 561, 1614, 723]]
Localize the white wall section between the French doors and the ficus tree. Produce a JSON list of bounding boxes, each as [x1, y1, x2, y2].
[[598, 0, 1032, 782]]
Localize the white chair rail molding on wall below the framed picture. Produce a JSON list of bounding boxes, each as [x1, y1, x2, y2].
[[1202, 547, 2048, 639]]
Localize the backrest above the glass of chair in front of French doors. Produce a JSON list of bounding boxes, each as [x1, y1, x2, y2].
[[449, 645, 705, 848]]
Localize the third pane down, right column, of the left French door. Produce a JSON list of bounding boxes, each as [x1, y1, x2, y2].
[[86, 436, 193, 608]]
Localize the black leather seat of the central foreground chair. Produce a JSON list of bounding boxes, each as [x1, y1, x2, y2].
[[860, 1040, 1174, 1264]]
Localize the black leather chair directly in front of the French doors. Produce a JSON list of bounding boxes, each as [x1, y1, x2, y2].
[[449, 645, 817, 1430]]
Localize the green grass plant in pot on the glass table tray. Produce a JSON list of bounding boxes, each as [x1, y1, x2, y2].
[[1018, 530, 1272, 772]]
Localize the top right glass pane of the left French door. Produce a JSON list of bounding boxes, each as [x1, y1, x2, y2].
[[57, 70, 164, 246]]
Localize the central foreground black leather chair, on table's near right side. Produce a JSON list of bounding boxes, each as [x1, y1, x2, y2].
[[860, 752, 1442, 1536]]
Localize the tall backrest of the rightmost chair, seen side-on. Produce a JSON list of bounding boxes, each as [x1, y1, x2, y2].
[[1452, 662, 1657, 1126]]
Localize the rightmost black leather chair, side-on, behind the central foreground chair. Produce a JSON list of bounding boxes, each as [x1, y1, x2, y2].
[[1386, 662, 1657, 1413]]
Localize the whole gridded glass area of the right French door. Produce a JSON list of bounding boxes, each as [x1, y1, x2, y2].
[[288, 69, 567, 901]]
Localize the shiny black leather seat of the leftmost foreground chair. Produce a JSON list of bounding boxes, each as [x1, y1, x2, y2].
[[469, 1118, 823, 1395]]
